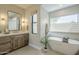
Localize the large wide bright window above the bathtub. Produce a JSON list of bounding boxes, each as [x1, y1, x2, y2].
[[50, 14, 79, 32]]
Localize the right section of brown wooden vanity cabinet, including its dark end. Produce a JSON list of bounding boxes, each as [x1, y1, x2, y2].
[[12, 34, 29, 49]]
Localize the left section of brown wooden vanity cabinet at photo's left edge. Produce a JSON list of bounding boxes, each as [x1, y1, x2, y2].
[[0, 36, 12, 54]]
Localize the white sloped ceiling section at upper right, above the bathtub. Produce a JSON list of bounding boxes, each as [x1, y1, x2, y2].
[[42, 4, 74, 12]]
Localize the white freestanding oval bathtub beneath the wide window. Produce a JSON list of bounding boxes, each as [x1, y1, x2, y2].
[[48, 37, 79, 55]]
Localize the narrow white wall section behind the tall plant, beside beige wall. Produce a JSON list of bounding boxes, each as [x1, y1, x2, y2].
[[40, 6, 49, 37]]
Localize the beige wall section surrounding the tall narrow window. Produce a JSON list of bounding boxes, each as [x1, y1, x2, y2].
[[26, 5, 40, 49]]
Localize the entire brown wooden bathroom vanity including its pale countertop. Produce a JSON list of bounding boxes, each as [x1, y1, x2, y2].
[[0, 33, 29, 54]]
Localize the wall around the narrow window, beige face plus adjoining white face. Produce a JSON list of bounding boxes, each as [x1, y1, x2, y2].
[[26, 5, 48, 49]]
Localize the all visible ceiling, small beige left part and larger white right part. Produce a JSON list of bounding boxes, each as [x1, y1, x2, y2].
[[16, 4, 74, 12]]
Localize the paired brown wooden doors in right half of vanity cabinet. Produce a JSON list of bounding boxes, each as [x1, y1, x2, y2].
[[13, 35, 25, 49]]
